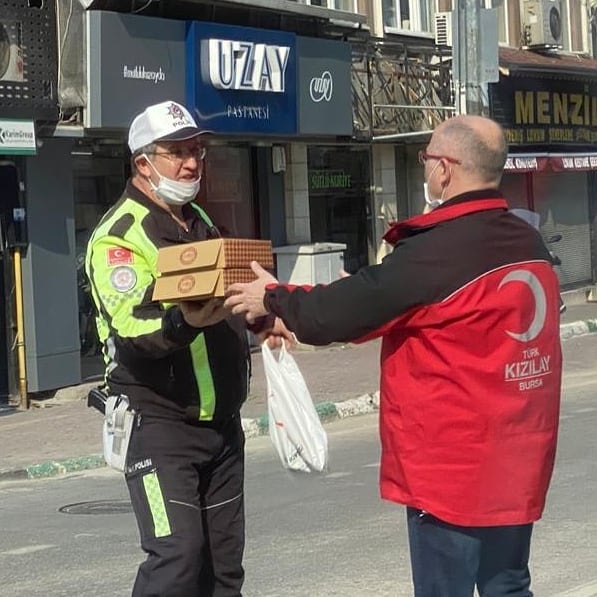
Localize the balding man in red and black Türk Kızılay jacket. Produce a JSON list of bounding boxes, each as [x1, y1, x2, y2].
[[226, 116, 562, 597]]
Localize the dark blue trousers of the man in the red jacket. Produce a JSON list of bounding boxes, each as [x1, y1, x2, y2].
[[407, 508, 533, 597]]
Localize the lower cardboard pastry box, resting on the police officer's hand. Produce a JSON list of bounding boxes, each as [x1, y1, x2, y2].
[[153, 268, 255, 302]]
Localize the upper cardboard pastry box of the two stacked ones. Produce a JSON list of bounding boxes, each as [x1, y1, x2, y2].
[[157, 238, 274, 274]]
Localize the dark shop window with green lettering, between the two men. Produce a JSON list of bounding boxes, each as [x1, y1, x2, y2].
[[308, 147, 371, 273]]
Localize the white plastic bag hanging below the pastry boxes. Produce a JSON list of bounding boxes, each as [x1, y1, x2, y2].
[[261, 343, 328, 472]]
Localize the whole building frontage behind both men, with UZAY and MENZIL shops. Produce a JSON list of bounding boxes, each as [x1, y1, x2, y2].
[[0, 0, 597, 400]]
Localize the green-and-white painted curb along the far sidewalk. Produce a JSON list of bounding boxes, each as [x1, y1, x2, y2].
[[0, 319, 597, 482]]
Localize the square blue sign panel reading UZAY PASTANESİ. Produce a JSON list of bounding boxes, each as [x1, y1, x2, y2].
[[186, 21, 297, 135]]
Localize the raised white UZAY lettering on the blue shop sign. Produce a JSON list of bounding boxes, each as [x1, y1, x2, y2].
[[204, 39, 290, 93]]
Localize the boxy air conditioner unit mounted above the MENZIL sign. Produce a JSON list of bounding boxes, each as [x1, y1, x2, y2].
[[522, 0, 562, 47]]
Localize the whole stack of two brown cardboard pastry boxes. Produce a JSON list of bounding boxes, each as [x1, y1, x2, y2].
[[153, 238, 274, 302]]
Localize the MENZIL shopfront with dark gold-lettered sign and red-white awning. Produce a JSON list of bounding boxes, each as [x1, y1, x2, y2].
[[489, 48, 597, 288]]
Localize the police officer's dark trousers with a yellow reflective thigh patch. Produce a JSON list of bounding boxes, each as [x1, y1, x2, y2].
[[125, 415, 245, 597]]
